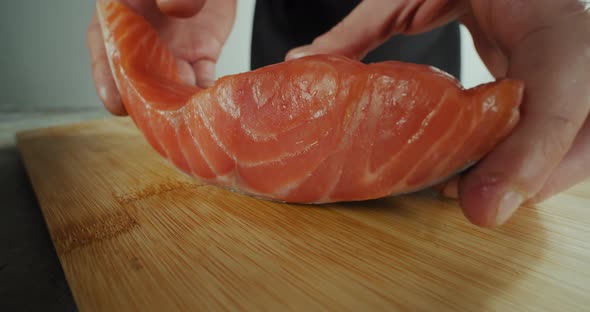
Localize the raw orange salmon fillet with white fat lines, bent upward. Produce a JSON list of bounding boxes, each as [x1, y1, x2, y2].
[[97, 0, 524, 203]]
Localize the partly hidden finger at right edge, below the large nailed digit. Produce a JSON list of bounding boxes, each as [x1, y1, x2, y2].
[[530, 119, 590, 203]]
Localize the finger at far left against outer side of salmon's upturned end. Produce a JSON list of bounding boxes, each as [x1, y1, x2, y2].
[[87, 13, 127, 116]]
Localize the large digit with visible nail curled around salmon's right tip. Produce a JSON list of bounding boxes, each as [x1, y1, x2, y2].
[[459, 17, 590, 226]]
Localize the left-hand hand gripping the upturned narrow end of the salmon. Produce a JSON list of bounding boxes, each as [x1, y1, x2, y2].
[[87, 0, 236, 115]]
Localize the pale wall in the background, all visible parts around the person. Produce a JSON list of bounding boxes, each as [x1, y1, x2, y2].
[[0, 0, 491, 112]]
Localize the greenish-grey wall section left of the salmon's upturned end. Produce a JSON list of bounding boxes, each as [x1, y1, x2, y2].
[[0, 0, 100, 112]]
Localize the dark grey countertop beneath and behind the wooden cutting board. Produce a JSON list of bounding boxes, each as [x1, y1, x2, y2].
[[0, 111, 106, 311]]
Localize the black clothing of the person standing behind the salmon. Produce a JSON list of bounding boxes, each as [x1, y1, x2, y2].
[[250, 0, 461, 79]]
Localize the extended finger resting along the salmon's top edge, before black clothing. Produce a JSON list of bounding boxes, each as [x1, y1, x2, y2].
[[286, 0, 465, 60]]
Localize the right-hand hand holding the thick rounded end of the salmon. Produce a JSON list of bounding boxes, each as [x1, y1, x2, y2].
[[287, 0, 590, 226]]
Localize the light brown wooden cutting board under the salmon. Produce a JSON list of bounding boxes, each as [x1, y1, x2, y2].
[[17, 118, 590, 311]]
